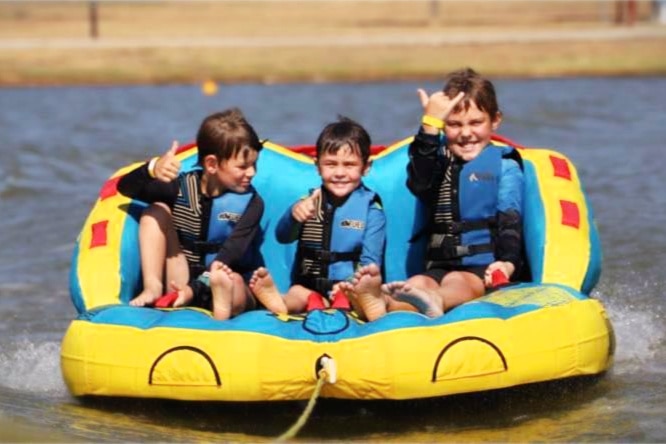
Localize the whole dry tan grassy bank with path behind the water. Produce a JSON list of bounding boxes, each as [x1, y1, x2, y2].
[[0, 0, 666, 86]]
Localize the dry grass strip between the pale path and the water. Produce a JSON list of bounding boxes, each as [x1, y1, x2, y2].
[[0, 38, 666, 88]]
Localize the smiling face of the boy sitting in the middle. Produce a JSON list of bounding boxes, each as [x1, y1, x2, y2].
[[316, 145, 370, 198]]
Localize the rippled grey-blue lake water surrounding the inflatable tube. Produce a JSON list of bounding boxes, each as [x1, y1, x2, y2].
[[0, 78, 666, 442]]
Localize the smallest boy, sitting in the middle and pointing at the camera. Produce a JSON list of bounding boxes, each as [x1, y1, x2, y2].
[[249, 117, 386, 314]]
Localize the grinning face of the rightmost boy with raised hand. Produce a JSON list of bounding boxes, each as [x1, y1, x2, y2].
[[444, 101, 502, 161]]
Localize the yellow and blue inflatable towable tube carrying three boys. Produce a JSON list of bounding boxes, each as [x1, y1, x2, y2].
[[61, 138, 614, 401]]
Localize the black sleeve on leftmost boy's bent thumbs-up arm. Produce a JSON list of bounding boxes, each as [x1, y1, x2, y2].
[[118, 163, 178, 207]]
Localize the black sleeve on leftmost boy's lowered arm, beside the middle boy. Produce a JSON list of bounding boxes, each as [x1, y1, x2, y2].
[[215, 194, 264, 268]]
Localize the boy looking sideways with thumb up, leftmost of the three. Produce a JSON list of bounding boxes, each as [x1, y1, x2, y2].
[[118, 108, 264, 319]]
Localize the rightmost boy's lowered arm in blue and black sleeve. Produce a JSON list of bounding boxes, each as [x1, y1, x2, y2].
[[495, 159, 524, 270]]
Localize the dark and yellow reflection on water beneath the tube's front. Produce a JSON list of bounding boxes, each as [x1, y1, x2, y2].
[[14, 378, 612, 442]]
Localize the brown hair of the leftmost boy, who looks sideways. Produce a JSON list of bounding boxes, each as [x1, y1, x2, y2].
[[197, 108, 262, 165]]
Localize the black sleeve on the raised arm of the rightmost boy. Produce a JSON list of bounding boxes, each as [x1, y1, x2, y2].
[[407, 127, 443, 199]]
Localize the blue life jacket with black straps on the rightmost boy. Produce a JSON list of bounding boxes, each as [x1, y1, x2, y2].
[[426, 145, 515, 267]]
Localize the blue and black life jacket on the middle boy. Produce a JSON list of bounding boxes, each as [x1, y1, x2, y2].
[[294, 185, 379, 295]]
